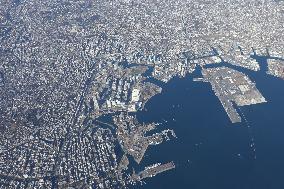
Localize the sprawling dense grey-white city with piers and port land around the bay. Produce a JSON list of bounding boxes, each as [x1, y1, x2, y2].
[[0, 0, 284, 189]]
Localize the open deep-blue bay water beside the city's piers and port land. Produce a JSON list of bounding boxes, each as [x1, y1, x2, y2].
[[134, 59, 284, 189]]
